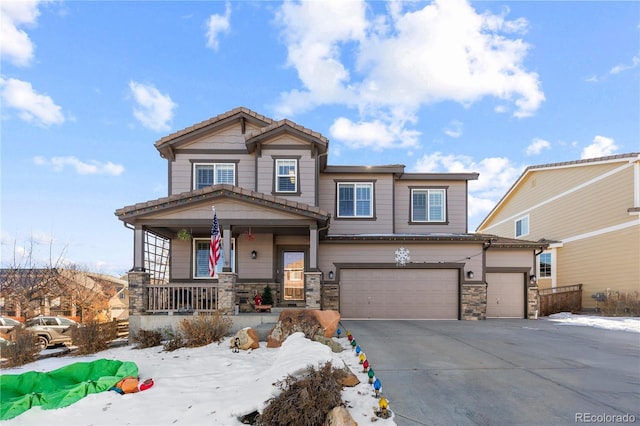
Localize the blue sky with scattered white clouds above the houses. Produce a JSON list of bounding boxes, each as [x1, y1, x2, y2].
[[0, 0, 640, 275]]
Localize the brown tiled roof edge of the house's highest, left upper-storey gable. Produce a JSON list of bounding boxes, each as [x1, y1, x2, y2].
[[155, 107, 273, 159]]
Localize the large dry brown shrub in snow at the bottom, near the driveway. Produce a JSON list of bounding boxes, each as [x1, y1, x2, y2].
[[256, 362, 346, 426]]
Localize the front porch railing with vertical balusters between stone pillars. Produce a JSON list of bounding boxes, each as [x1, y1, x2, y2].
[[147, 283, 218, 314]]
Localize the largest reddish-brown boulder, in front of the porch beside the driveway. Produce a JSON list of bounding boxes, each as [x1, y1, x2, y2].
[[267, 309, 340, 348]]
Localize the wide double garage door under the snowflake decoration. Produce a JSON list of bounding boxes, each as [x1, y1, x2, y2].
[[340, 269, 459, 319]]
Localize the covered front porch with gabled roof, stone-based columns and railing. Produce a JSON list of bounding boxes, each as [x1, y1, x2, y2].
[[116, 185, 329, 322]]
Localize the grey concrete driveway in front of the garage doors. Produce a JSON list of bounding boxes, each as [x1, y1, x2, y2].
[[342, 319, 640, 426]]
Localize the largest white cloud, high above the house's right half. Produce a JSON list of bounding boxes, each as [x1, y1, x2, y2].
[[277, 0, 545, 146]]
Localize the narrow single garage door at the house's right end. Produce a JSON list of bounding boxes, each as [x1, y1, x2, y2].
[[487, 273, 525, 318]]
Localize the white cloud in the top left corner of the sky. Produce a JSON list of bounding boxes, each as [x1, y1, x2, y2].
[[0, 0, 47, 67]]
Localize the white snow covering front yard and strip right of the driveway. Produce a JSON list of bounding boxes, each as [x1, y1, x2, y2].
[[1, 313, 640, 426]]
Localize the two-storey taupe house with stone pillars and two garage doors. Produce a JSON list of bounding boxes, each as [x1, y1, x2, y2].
[[116, 108, 546, 327]]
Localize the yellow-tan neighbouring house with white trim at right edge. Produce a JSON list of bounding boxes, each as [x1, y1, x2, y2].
[[477, 153, 640, 310]]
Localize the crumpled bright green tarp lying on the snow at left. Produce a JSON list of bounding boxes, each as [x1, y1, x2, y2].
[[0, 359, 138, 420]]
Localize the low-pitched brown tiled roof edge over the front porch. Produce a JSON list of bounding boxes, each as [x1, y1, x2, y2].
[[115, 184, 330, 223]]
